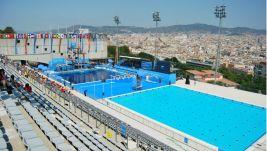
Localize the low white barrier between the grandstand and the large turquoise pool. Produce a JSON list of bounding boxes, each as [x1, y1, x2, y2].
[[100, 99, 218, 151]]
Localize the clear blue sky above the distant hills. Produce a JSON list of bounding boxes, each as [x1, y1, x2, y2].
[[0, 0, 266, 32]]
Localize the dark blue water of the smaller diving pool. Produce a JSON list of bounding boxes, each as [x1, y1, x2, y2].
[[57, 69, 120, 84]]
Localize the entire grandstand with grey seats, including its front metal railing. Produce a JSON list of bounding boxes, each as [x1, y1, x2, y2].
[[0, 59, 178, 151]]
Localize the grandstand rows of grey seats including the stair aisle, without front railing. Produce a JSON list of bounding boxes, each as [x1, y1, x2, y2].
[[0, 65, 130, 151]]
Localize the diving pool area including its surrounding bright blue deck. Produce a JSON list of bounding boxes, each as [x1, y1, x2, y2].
[[47, 58, 176, 99]]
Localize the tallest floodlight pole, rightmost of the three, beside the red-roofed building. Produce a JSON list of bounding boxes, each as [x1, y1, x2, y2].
[[214, 5, 226, 84]]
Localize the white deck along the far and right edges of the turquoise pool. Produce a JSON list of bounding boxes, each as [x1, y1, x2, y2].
[[177, 80, 267, 151]]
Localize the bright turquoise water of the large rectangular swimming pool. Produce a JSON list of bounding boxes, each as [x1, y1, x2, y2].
[[112, 86, 266, 151]]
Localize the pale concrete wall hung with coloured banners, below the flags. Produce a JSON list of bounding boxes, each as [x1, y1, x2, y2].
[[0, 34, 107, 63]]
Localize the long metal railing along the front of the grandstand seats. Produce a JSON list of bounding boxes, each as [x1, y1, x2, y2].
[[2, 61, 178, 151]]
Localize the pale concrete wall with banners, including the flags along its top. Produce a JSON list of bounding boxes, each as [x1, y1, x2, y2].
[[0, 33, 107, 60]]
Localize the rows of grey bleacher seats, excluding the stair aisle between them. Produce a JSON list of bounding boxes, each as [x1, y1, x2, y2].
[[0, 66, 124, 151]]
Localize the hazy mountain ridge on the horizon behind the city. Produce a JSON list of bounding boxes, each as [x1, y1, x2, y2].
[[38, 23, 266, 35]]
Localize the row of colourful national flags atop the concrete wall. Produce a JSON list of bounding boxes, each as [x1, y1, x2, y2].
[[0, 33, 106, 40]]
